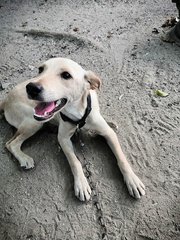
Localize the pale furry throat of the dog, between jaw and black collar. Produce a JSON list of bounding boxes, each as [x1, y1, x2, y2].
[[62, 90, 89, 121]]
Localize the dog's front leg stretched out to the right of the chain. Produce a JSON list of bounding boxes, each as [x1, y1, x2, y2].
[[90, 113, 145, 198]]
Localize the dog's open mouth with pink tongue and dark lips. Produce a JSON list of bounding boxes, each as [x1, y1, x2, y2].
[[34, 98, 67, 121]]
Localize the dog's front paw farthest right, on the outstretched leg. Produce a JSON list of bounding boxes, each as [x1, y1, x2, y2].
[[124, 172, 145, 198]]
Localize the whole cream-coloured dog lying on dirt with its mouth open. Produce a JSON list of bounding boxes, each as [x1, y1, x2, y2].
[[0, 58, 145, 201]]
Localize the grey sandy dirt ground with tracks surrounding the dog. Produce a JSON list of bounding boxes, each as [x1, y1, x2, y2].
[[0, 0, 180, 240]]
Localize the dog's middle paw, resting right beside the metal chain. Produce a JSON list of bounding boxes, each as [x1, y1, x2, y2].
[[74, 176, 91, 201]]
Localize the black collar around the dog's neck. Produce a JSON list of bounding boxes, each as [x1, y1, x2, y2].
[[60, 94, 92, 129]]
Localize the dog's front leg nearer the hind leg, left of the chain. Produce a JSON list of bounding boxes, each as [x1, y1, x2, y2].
[[58, 123, 91, 201]]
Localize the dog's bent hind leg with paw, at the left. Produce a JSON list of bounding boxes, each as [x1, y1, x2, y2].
[[6, 121, 43, 169]]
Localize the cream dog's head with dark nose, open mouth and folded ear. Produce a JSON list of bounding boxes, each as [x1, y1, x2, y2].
[[26, 58, 101, 121]]
